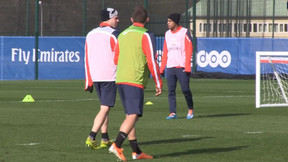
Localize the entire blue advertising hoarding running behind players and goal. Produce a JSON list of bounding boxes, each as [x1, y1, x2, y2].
[[0, 36, 288, 80]]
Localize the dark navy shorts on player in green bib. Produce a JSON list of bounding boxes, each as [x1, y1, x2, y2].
[[117, 84, 144, 117]]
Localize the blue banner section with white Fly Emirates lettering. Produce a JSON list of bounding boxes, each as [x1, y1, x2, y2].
[[0, 37, 85, 80]]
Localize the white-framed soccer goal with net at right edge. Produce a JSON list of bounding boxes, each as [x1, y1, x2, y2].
[[256, 51, 288, 108]]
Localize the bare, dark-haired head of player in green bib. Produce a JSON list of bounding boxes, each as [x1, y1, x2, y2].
[[131, 5, 149, 24]]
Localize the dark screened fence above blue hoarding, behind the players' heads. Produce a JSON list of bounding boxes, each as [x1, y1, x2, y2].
[[0, 0, 199, 36]]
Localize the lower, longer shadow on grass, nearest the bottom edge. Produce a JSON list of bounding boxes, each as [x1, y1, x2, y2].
[[154, 146, 248, 158]]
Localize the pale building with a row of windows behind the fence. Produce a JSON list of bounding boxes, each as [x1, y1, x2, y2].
[[188, 0, 288, 38]]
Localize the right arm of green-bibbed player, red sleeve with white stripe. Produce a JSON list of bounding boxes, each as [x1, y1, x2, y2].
[[142, 32, 162, 95]]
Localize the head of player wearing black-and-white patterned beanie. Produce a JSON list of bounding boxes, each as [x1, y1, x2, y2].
[[101, 8, 119, 28]]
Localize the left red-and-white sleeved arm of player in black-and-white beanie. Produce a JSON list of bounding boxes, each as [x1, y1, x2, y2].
[[84, 42, 93, 93]]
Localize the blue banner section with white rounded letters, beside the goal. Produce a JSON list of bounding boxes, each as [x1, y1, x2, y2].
[[197, 38, 288, 75]]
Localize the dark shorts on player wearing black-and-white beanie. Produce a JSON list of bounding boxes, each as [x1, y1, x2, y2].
[[94, 81, 116, 107]]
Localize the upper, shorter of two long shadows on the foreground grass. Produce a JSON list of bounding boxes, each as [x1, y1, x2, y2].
[[138, 137, 214, 145]]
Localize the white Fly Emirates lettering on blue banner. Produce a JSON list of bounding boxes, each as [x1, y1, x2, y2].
[[11, 48, 80, 65]]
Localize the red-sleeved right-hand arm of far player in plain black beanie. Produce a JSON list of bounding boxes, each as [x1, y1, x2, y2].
[[185, 31, 193, 73]]
